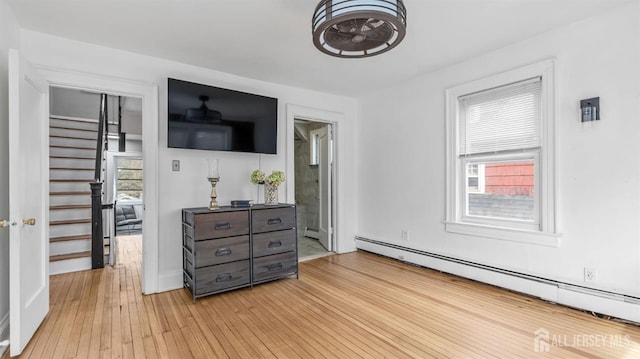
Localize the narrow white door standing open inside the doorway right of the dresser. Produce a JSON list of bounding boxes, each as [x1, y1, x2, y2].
[[311, 125, 333, 251]]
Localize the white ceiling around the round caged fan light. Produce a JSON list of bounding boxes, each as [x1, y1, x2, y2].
[[7, 0, 630, 97]]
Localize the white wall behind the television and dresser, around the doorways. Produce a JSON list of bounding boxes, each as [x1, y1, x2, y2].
[[22, 30, 357, 289]]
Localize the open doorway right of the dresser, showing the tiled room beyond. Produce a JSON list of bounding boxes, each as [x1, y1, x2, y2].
[[294, 119, 335, 260]]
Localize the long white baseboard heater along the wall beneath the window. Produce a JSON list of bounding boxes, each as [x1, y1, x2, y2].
[[356, 237, 640, 323]]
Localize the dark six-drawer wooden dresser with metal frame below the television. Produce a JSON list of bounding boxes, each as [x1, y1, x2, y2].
[[182, 204, 298, 302]]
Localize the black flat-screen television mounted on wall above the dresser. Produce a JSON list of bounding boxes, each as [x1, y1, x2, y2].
[[168, 78, 278, 154]]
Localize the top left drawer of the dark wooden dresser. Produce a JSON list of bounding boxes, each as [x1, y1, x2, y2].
[[193, 211, 249, 241]]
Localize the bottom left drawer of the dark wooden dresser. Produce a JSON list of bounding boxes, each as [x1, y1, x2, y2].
[[195, 260, 251, 295]]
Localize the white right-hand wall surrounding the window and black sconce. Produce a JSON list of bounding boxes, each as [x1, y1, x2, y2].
[[357, 2, 640, 296]]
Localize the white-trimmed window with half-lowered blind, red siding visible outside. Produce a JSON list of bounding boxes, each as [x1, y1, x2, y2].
[[446, 61, 557, 245]]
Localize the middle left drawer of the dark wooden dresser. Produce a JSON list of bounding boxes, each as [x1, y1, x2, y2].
[[194, 236, 249, 268]]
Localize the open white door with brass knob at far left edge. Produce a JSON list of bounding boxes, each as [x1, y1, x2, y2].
[[9, 49, 49, 356]]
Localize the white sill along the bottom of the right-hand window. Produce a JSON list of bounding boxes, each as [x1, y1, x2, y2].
[[444, 222, 562, 248]]
